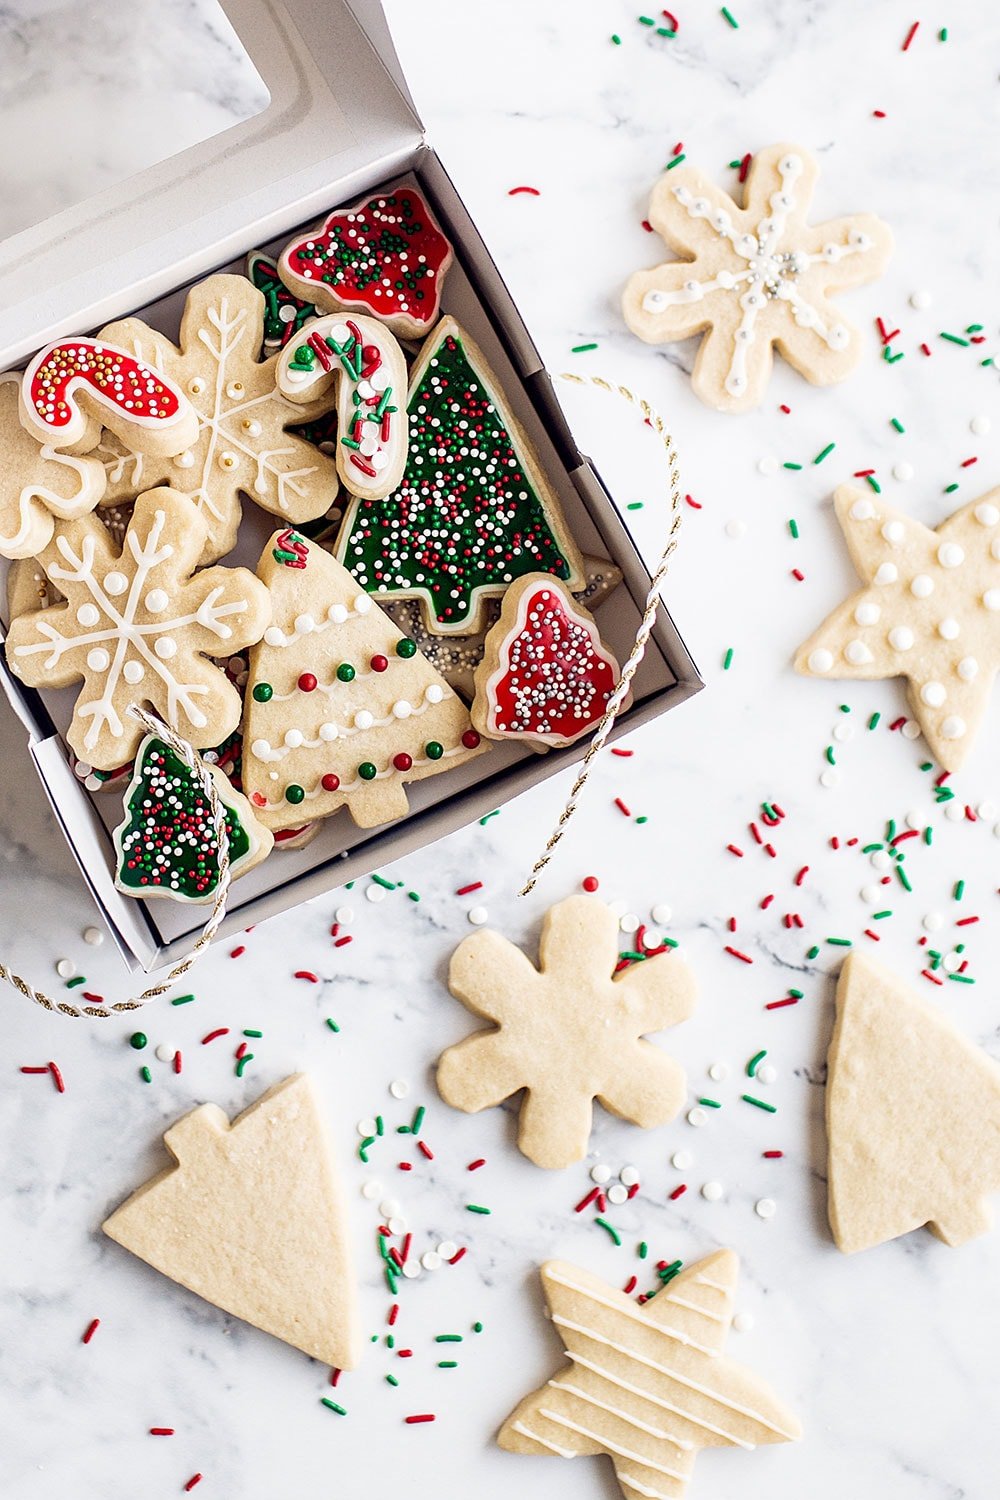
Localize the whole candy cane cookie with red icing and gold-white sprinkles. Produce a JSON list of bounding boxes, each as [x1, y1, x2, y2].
[[21, 339, 198, 458]]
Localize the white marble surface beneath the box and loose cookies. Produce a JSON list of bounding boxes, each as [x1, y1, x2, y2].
[[0, 0, 1000, 1500]]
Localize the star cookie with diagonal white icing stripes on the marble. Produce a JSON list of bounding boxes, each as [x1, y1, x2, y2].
[[498, 1250, 802, 1500]]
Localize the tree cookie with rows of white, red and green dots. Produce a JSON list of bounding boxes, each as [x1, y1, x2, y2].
[[243, 531, 486, 830]]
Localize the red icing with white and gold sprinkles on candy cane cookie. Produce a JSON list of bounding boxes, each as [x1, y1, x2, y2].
[[25, 339, 181, 432]]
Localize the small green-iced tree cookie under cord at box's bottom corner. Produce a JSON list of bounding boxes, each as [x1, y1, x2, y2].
[[112, 735, 274, 903]]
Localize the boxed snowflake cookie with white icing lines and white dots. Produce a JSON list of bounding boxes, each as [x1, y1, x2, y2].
[[6, 489, 271, 771]]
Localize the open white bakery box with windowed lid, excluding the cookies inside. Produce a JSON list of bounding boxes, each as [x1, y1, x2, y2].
[[0, 0, 702, 969]]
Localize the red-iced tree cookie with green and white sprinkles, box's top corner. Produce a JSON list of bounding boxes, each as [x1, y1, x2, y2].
[[277, 188, 451, 339]]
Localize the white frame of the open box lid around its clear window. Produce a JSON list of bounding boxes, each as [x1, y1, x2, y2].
[[0, 0, 423, 366]]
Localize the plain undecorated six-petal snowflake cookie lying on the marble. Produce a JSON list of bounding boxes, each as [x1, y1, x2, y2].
[[438, 896, 696, 1167]]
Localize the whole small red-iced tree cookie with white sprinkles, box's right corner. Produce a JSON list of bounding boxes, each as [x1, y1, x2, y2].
[[472, 573, 621, 749]]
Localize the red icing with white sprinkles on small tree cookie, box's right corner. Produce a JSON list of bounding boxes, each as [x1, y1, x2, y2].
[[489, 584, 618, 744]]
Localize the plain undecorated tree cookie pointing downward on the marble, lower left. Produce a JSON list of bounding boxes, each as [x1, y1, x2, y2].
[[102, 1074, 360, 1370]]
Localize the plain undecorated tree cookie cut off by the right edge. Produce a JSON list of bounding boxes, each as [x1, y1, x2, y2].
[[826, 953, 1000, 1253]]
